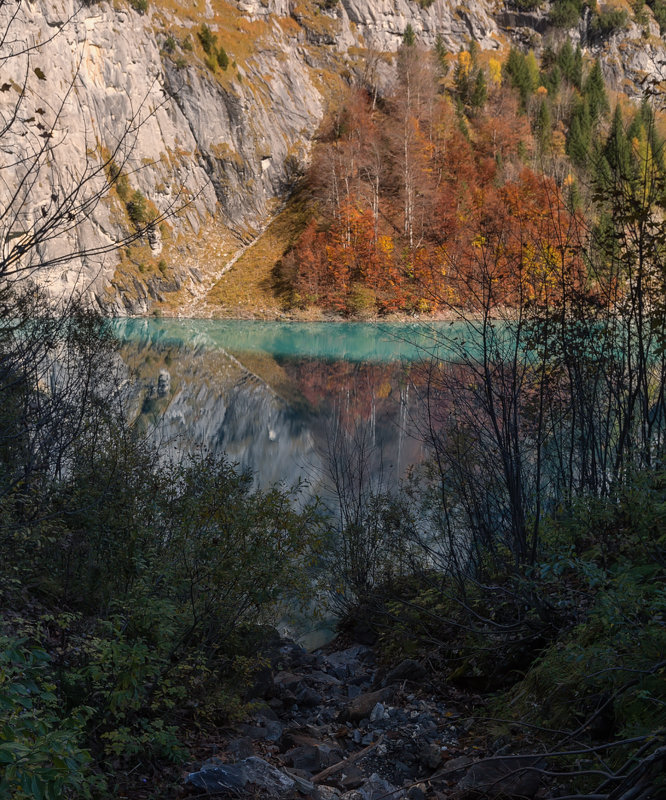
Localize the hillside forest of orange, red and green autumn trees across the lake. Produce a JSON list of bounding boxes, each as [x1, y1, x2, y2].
[[278, 36, 663, 316]]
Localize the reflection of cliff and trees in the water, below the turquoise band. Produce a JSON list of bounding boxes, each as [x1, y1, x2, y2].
[[124, 346, 423, 491]]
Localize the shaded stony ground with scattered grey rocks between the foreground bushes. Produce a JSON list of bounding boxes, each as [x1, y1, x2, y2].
[[180, 641, 545, 800]]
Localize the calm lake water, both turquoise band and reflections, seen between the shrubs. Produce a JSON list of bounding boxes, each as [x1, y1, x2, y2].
[[113, 319, 464, 493]]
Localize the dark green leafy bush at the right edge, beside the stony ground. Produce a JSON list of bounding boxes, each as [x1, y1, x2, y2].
[[504, 473, 666, 738]]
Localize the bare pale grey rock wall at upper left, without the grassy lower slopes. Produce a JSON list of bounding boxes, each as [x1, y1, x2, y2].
[[0, 0, 323, 312]]
